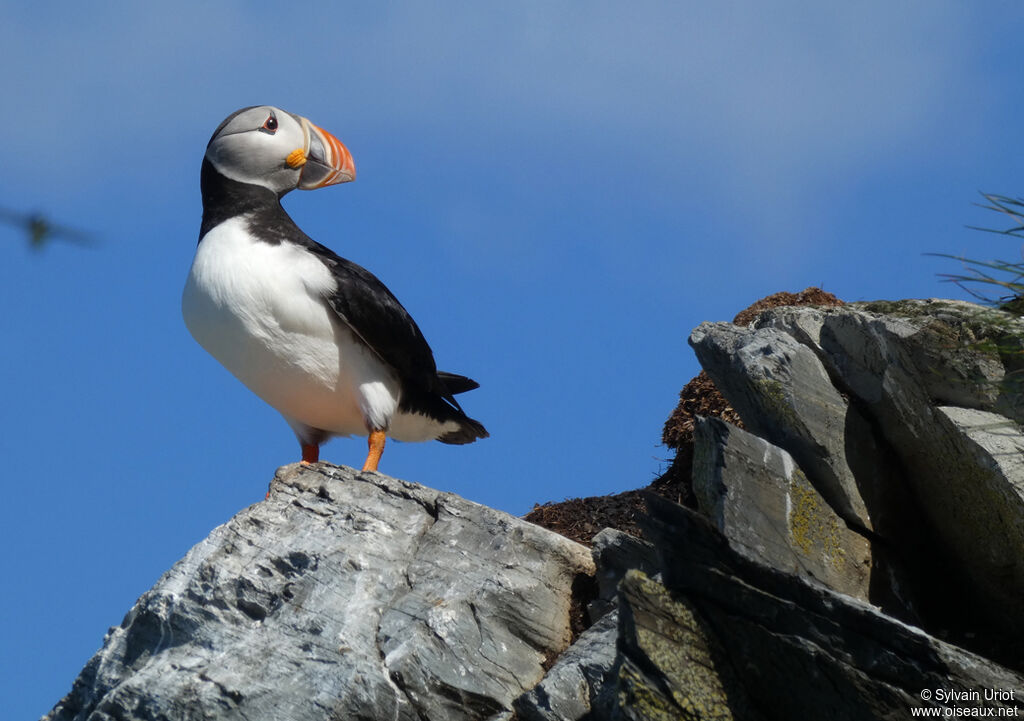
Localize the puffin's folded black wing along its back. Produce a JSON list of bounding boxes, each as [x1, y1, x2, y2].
[[310, 243, 460, 403]]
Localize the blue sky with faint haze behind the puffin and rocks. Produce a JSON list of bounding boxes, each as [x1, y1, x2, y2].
[[0, 0, 1024, 719]]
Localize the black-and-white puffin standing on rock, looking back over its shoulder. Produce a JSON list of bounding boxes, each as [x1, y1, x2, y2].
[[181, 105, 488, 471]]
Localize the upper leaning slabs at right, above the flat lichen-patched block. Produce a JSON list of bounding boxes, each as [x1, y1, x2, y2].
[[691, 301, 1024, 664]]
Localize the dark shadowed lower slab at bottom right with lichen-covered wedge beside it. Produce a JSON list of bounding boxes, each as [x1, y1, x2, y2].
[[516, 497, 1024, 721]]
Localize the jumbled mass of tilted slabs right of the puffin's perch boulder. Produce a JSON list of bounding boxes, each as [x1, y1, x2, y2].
[[516, 294, 1024, 721]]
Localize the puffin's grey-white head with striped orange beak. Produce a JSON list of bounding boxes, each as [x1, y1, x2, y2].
[[206, 105, 355, 196]]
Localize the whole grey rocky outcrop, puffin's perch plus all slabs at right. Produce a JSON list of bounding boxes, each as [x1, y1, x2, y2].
[[46, 294, 1024, 721]]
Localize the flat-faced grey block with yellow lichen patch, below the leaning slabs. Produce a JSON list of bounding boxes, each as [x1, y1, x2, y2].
[[693, 418, 871, 600]]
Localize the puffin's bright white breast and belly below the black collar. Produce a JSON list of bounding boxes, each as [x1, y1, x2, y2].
[[181, 216, 398, 435]]
